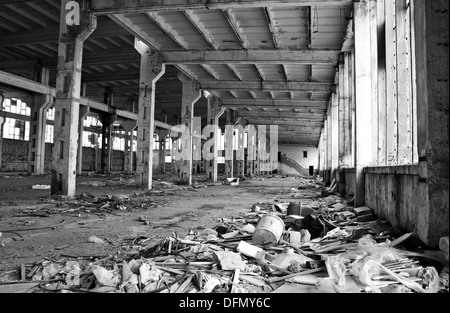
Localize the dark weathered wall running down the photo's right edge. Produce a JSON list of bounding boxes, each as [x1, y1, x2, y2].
[[425, 0, 449, 244]]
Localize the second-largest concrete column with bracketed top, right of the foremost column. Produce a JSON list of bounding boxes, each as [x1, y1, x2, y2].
[[134, 39, 166, 190]]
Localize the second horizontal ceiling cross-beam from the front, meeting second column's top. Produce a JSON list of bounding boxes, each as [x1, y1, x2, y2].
[[162, 49, 340, 64]]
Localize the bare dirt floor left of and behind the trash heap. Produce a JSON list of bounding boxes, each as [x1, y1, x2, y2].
[[0, 173, 320, 271]]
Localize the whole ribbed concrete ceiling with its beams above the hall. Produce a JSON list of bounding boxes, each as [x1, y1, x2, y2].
[[0, 0, 352, 146]]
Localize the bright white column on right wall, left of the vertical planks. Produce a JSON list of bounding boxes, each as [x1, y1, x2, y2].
[[354, 1, 378, 207]]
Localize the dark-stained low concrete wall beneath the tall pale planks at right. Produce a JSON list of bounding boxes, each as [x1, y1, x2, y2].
[[365, 165, 428, 243]]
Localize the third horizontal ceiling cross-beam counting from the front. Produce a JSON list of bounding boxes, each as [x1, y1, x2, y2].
[[199, 80, 332, 93]]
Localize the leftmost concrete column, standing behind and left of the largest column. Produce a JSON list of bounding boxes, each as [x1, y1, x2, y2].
[[28, 68, 53, 175]]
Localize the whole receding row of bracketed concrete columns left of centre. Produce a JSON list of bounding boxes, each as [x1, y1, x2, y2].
[[46, 0, 282, 196]]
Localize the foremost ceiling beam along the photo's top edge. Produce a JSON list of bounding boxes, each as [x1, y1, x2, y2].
[[92, 0, 353, 14]]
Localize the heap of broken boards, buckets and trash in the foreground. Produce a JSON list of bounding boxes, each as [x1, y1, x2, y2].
[[0, 190, 449, 293]]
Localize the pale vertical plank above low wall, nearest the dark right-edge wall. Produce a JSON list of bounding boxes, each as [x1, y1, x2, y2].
[[396, 0, 413, 164]]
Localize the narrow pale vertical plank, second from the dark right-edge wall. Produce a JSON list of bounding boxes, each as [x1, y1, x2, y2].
[[385, 0, 398, 165]]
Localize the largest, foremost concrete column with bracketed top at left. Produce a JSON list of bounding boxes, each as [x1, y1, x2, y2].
[[51, 0, 97, 198]]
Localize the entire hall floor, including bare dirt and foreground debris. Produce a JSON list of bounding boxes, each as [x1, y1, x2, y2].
[[0, 175, 448, 293]]
